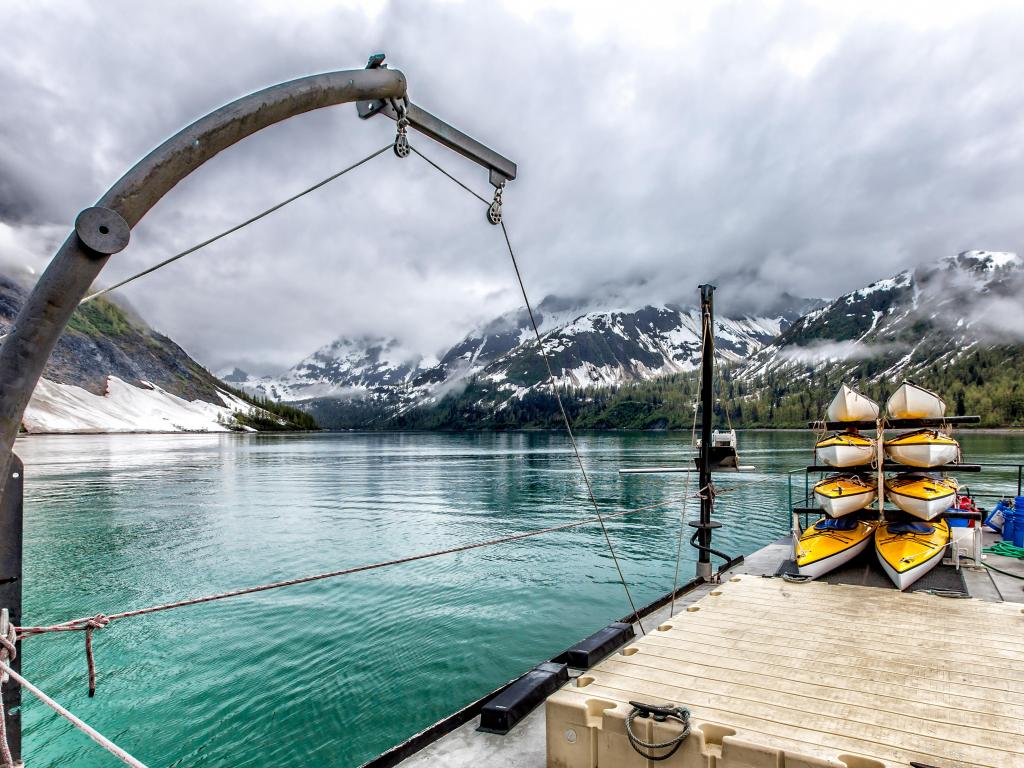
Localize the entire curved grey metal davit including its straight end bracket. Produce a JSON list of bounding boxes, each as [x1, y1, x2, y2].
[[0, 54, 516, 494]]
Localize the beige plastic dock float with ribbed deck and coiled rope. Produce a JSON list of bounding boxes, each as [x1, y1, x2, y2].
[[546, 575, 1024, 768]]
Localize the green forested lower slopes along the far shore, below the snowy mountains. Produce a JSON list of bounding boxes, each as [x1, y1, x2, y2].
[[381, 346, 1024, 430]]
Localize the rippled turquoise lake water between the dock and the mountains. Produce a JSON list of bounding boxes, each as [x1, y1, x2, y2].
[[16, 432, 1024, 768]]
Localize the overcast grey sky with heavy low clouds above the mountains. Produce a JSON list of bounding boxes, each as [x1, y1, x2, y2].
[[0, 0, 1024, 373]]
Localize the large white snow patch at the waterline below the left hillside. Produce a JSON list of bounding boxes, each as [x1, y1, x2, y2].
[[22, 376, 264, 434]]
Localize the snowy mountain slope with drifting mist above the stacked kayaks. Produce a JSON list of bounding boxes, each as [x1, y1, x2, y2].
[[740, 251, 1024, 380]]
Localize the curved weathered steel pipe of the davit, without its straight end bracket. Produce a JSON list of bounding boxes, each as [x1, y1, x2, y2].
[[0, 69, 406, 493]]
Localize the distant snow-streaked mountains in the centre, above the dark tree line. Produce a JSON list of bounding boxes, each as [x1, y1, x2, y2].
[[235, 297, 808, 428]]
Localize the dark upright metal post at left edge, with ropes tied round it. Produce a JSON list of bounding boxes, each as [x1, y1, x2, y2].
[[0, 455, 25, 764]]
